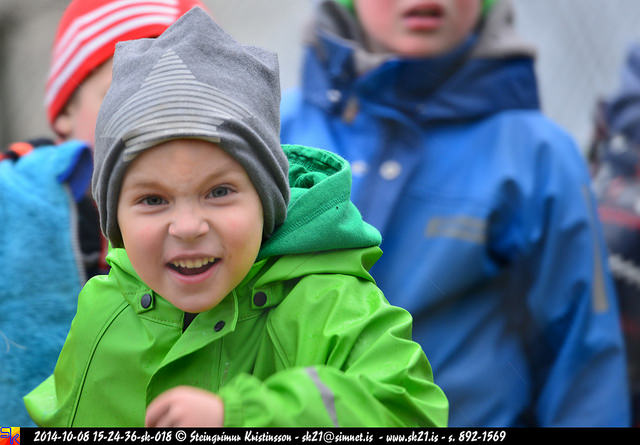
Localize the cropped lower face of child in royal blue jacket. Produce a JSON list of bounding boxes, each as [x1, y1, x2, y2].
[[354, 0, 481, 57]]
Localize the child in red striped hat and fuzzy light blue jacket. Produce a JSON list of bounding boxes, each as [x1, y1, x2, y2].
[[0, 0, 201, 426]]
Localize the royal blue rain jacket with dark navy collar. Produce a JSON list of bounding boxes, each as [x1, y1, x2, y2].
[[281, 2, 629, 426]]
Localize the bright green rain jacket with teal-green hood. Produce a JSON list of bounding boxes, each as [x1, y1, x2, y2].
[[25, 146, 448, 427]]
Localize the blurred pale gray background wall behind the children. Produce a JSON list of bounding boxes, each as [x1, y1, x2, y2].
[[0, 0, 640, 151]]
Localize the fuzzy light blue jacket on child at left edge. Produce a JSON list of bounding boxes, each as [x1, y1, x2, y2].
[[0, 141, 92, 426]]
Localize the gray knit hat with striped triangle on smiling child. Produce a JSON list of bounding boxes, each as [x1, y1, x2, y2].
[[92, 7, 289, 247]]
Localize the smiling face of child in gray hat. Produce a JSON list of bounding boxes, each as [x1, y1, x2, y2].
[[118, 139, 263, 312]]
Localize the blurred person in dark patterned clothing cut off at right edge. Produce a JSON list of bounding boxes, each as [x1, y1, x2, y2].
[[590, 43, 640, 426]]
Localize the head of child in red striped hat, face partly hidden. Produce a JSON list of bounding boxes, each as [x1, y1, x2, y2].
[[45, 0, 208, 143]]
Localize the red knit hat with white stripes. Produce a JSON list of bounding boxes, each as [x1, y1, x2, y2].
[[45, 0, 205, 125]]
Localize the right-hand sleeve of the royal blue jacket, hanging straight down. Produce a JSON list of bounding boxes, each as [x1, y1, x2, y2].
[[518, 126, 630, 426]]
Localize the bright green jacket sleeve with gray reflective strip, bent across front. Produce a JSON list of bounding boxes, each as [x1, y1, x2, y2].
[[220, 275, 448, 427]]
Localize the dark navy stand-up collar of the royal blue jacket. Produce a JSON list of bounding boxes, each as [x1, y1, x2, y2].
[[303, 27, 540, 123]]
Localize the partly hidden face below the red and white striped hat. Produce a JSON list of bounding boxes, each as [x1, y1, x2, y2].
[[53, 59, 113, 147]]
